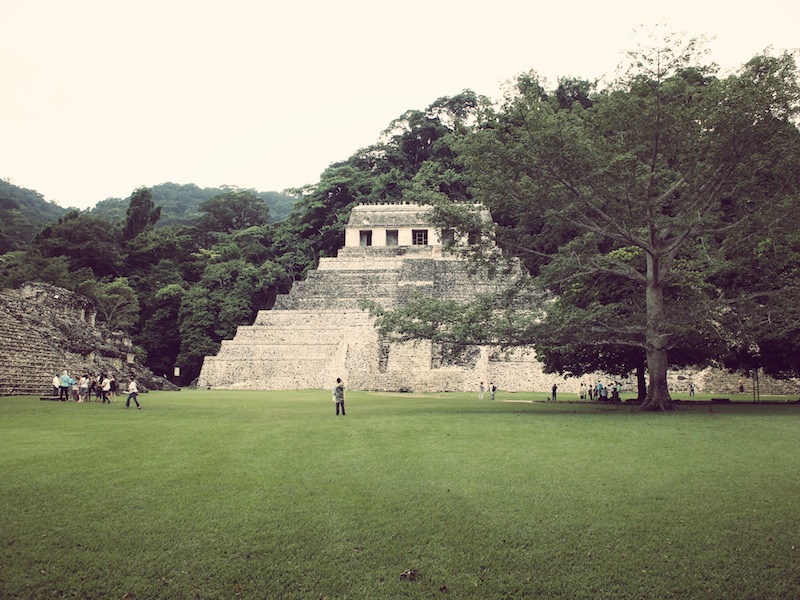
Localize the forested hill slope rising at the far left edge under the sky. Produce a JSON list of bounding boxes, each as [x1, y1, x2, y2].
[[0, 179, 67, 254]]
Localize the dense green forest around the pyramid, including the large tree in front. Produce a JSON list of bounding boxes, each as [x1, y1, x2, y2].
[[0, 36, 800, 398]]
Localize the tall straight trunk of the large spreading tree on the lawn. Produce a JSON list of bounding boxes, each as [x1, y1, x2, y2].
[[641, 253, 673, 410]]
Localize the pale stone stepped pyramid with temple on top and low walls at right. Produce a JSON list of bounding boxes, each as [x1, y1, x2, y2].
[[198, 203, 799, 393]]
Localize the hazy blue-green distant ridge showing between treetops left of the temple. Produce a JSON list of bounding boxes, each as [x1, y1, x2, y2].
[[89, 183, 297, 228]]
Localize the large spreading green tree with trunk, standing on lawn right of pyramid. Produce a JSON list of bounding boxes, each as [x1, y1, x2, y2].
[[376, 38, 800, 410]]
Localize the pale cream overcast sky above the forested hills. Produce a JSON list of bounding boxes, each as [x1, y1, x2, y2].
[[0, 0, 800, 208]]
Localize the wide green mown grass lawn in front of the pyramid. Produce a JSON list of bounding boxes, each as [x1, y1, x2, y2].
[[0, 390, 800, 600]]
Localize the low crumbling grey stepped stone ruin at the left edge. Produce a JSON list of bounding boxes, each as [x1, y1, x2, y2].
[[0, 283, 177, 396]]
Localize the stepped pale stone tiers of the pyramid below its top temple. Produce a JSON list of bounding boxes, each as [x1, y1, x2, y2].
[[198, 246, 529, 392]]
